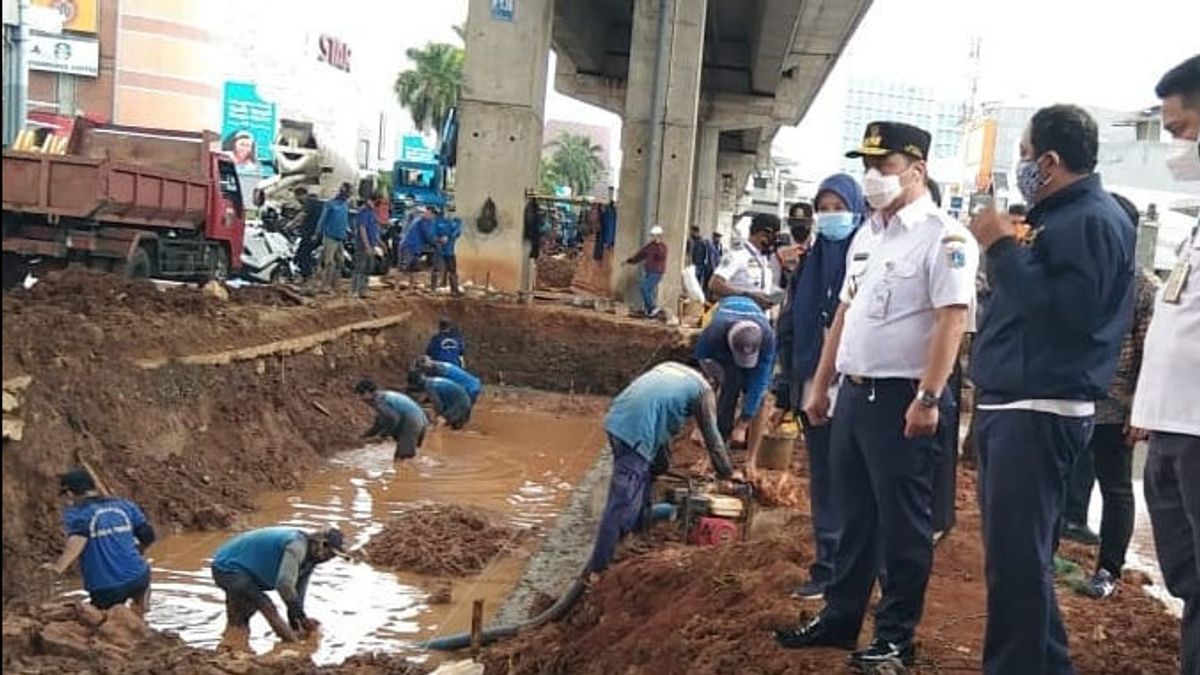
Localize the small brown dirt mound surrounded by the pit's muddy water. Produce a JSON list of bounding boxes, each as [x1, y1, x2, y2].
[[366, 504, 523, 577]]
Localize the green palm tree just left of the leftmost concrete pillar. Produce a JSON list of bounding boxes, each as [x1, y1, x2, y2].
[[395, 42, 463, 145]]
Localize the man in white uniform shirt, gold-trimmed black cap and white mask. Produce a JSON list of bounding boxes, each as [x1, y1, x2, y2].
[[775, 123, 979, 670]]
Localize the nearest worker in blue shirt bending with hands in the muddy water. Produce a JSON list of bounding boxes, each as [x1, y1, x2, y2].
[[212, 527, 346, 646]]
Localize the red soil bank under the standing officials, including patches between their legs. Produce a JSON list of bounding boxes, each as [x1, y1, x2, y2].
[[485, 441, 1180, 675]]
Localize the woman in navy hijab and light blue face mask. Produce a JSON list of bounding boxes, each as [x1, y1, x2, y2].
[[786, 173, 866, 599]]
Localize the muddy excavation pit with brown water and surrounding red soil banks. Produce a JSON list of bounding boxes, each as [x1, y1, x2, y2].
[[2, 270, 1178, 675]]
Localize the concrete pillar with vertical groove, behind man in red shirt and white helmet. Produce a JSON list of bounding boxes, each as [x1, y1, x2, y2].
[[612, 0, 708, 311]]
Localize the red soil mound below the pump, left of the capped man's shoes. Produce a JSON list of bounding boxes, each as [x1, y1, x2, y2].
[[485, 538, 821, 675]]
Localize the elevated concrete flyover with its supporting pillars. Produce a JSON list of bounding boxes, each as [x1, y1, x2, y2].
[[457, 0, 870, 306]]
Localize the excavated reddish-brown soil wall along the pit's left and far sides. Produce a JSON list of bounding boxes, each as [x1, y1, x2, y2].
[[2, 271, 686, 607]]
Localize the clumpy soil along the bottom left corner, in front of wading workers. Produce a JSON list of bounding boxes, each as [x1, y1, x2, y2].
[[4, 602, 432, 675]]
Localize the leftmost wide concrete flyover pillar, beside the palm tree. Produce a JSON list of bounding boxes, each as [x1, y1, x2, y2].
[[455, 0, 554, 291]]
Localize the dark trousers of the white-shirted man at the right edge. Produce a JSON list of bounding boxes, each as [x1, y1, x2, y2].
[[1145, 432, 1200, 675]]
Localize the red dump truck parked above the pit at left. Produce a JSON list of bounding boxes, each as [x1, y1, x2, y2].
[[2, 118, 245, 287]]
